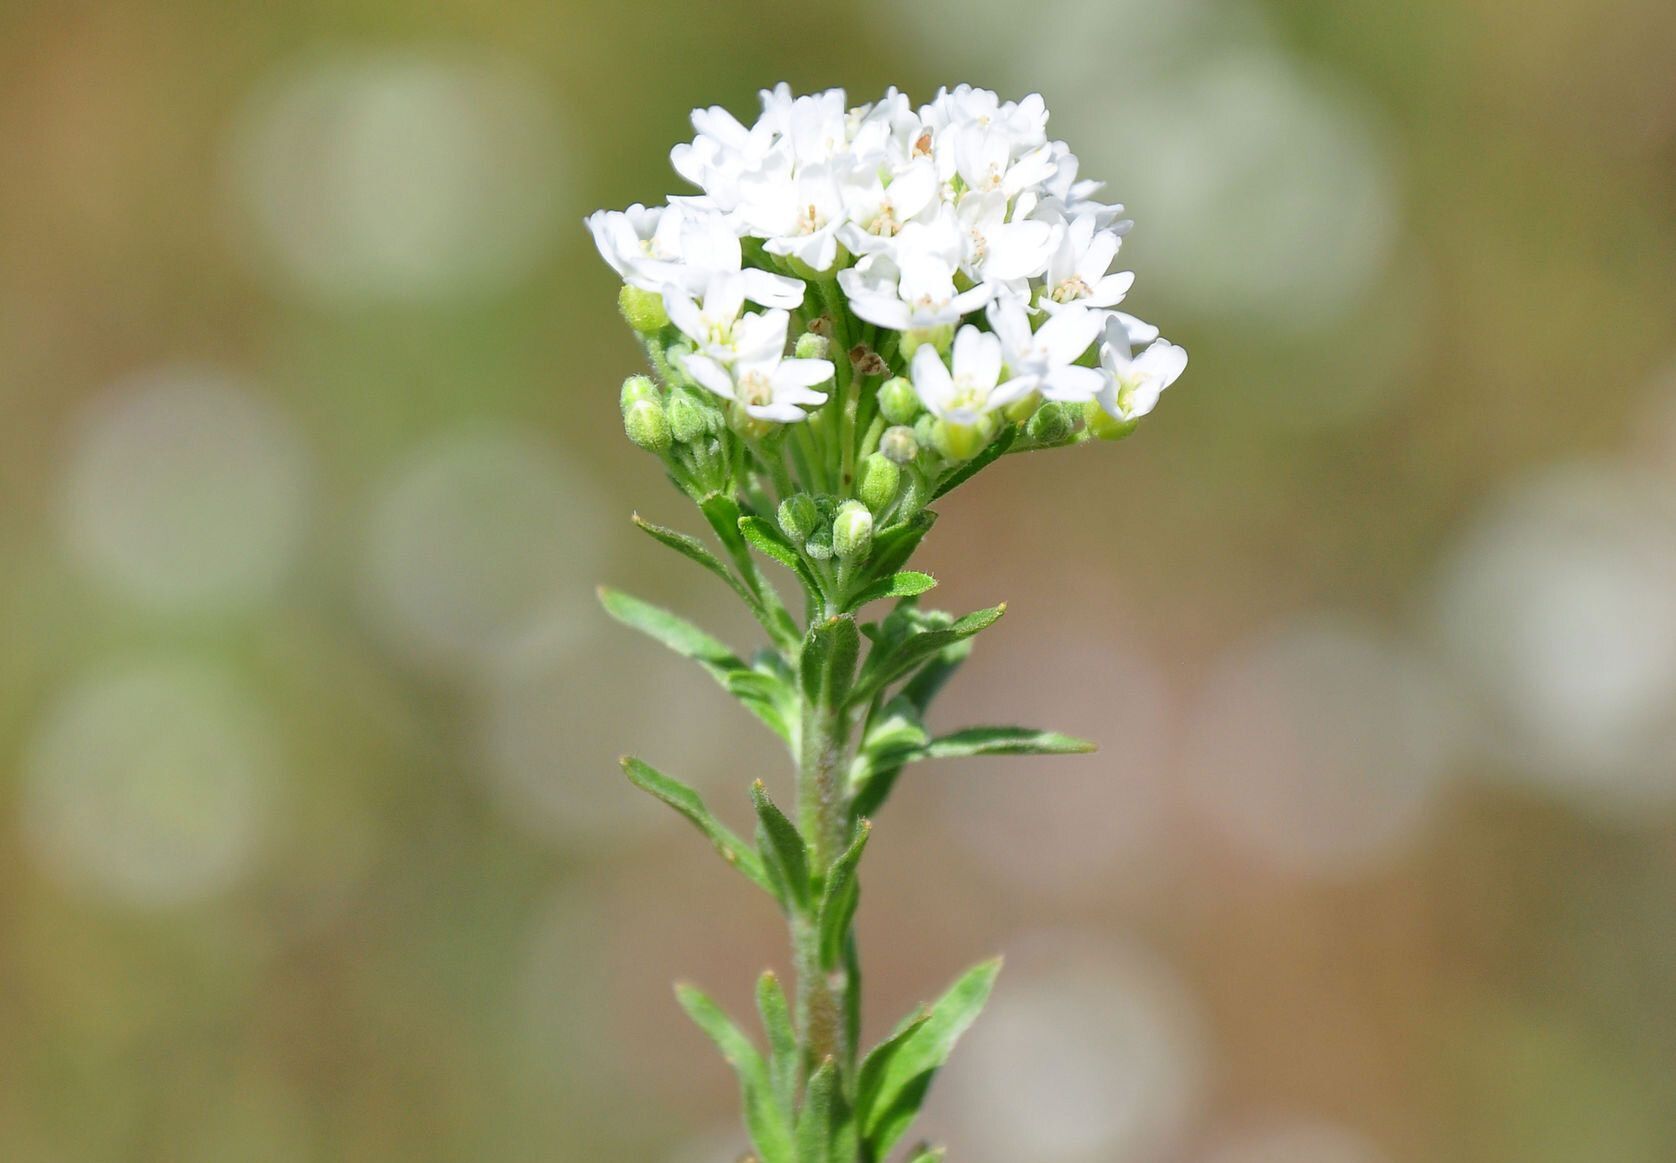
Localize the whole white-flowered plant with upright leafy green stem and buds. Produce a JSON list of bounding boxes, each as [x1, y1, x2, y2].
[[588, 85, 1187, 1163]]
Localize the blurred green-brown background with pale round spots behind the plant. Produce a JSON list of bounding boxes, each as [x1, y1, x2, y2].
[[0, 0, 1676, 1163]]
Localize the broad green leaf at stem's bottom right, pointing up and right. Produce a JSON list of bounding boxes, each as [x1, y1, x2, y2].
[[856, 959, 1001, 1158]]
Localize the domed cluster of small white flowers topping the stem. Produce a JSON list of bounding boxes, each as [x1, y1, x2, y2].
[[588, 85, 1187, 424]]
